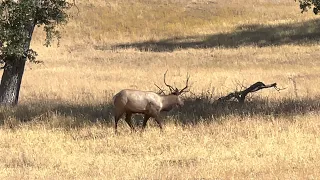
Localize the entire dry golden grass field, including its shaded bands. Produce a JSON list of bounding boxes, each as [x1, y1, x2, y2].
[[0, 0, 320, 179]]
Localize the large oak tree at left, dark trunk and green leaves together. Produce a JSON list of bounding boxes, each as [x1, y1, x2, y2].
[[0, 0, 72, 105]]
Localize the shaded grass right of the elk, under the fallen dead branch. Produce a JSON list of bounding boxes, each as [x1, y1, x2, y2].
[[171, 97, 320, 124]]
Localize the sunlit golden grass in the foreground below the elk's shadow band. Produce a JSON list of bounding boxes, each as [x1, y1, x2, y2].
[[0, 115, 320, 179]]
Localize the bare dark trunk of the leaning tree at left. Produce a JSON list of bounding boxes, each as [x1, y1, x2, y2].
[[0, 58, 26, 105]]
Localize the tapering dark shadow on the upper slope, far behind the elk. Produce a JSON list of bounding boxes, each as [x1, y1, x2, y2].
[[107, 19, 320, 52]]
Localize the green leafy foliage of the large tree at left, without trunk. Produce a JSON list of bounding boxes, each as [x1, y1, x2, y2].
[[0, 0, 71, 63]]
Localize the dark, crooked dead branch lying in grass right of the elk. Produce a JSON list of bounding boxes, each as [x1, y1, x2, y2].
[[218, 82, 285, 103]]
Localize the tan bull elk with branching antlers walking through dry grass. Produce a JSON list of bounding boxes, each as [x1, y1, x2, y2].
[[113, 71, 190, 133]]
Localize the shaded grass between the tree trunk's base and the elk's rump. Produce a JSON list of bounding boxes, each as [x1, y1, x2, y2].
[[0, 100, 113, 129]]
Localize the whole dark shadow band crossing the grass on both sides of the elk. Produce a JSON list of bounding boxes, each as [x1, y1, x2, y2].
[[0, 96, 320, 129]]
